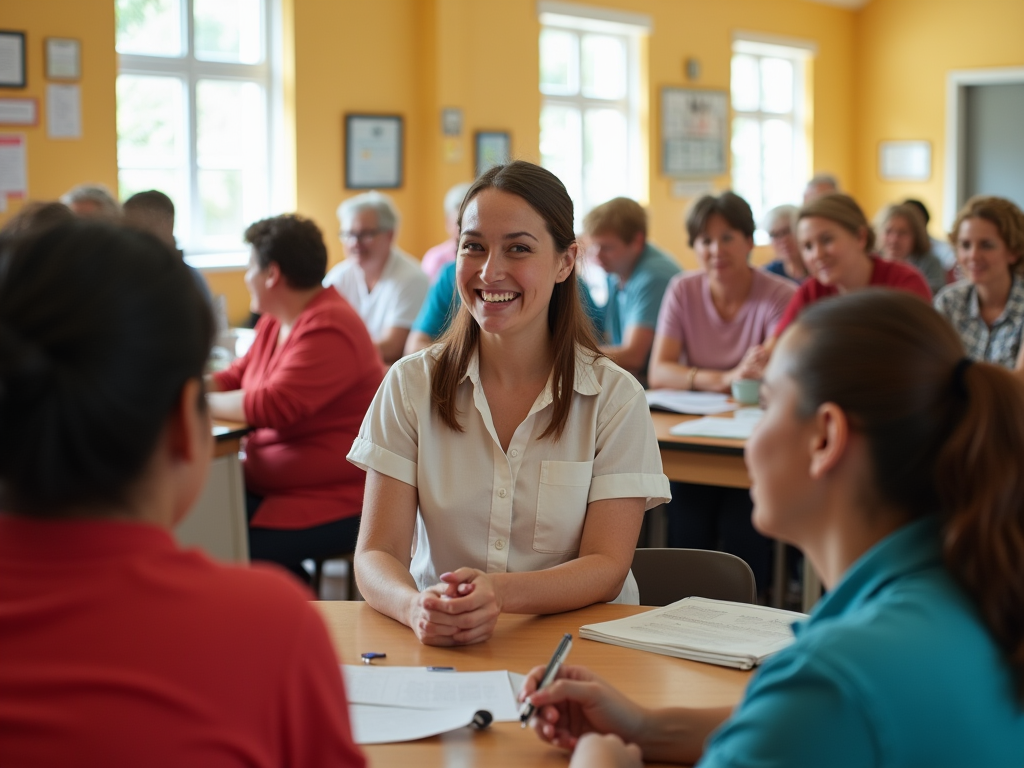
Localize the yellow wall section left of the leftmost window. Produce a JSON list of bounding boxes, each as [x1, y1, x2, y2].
[[0, 0, 118, 217]]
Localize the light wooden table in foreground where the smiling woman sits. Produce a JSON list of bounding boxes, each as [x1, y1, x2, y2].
[[314, 601, 751, 768]]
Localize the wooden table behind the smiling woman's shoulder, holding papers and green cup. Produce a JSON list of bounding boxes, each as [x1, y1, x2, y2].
[[650, 411, 821, 611]]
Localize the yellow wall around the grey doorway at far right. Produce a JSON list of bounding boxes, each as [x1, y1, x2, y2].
[[853, 0, 1024, 237]]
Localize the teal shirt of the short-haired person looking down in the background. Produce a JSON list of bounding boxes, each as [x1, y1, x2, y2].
[[604, 243, 682, 346]]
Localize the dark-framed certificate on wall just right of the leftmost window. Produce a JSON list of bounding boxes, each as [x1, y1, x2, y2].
[[345, 115, 402, 189]]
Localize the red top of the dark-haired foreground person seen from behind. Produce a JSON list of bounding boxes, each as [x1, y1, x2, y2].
[[0, 518, 366, 768]]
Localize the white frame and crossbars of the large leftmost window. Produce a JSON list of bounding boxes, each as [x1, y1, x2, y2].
[[117, 0, 284, 270]]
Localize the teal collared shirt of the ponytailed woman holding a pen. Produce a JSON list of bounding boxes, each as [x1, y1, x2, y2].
[[699, 519, 1024, 768]]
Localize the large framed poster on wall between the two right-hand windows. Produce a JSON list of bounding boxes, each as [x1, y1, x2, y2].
[[662, 88, 729, 178]]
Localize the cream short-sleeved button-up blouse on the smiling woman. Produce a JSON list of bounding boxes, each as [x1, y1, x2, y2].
[[348, 348, 670, 604]]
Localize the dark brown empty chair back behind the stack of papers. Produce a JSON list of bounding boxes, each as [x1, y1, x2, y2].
[[632, 549, 757, 606]]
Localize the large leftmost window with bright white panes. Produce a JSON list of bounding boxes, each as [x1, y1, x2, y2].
[[116, 0, 273, 266]]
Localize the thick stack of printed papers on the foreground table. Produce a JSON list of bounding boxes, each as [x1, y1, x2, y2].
[[580, 597, 807, 670]]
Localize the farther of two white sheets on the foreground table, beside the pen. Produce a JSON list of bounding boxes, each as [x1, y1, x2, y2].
[[341, 665, 519, 723]]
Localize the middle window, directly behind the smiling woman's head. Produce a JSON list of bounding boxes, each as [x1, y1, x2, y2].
[[540, 2, 650, 228]]
